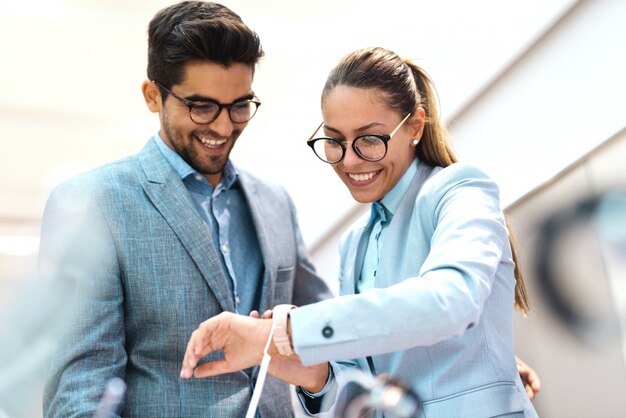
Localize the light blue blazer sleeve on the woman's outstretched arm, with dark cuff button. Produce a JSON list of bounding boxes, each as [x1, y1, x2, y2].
[[290, 166, 512, 365]]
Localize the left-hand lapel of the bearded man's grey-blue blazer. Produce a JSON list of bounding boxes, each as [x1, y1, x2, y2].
[[139, 141, 235, 311]]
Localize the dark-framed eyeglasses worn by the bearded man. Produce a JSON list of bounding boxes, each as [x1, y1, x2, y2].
[[153, 80, 261, 125]]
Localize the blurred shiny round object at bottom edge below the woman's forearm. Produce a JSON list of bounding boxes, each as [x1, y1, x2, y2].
[[334, 372, 421, 418]]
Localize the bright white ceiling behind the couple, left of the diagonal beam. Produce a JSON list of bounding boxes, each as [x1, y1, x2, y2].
[[0, 0, 574, 248]]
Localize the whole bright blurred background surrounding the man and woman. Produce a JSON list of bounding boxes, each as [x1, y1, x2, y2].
[[0, 0, 626, 418]]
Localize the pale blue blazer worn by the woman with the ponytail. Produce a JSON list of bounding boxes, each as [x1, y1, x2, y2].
[[291, 158, 536, 418]]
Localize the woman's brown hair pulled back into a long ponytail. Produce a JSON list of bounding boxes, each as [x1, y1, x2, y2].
[[322, 47, 529, 314]]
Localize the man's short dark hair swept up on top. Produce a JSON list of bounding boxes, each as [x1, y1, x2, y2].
[[148, 1, 263, 87]]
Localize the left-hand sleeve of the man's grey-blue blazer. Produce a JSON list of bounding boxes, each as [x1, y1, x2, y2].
[[39, 184, 126, 417]]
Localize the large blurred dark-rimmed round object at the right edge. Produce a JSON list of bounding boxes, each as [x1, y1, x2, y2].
[[536, 190, 626, 350]]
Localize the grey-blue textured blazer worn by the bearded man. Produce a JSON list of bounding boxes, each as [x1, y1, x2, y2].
[[40, 141, 330, 418]]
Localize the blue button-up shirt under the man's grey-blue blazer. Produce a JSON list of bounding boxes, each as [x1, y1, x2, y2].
[[154, 134, 264, 315]]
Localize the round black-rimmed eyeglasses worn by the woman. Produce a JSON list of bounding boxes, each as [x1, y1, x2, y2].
[[306, 113, 411, 164]]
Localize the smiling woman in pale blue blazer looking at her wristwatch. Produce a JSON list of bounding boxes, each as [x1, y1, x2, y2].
[[181, 48, 536, 417]]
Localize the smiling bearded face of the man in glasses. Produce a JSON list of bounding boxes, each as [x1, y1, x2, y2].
[[159, 62, 253, 187]]
